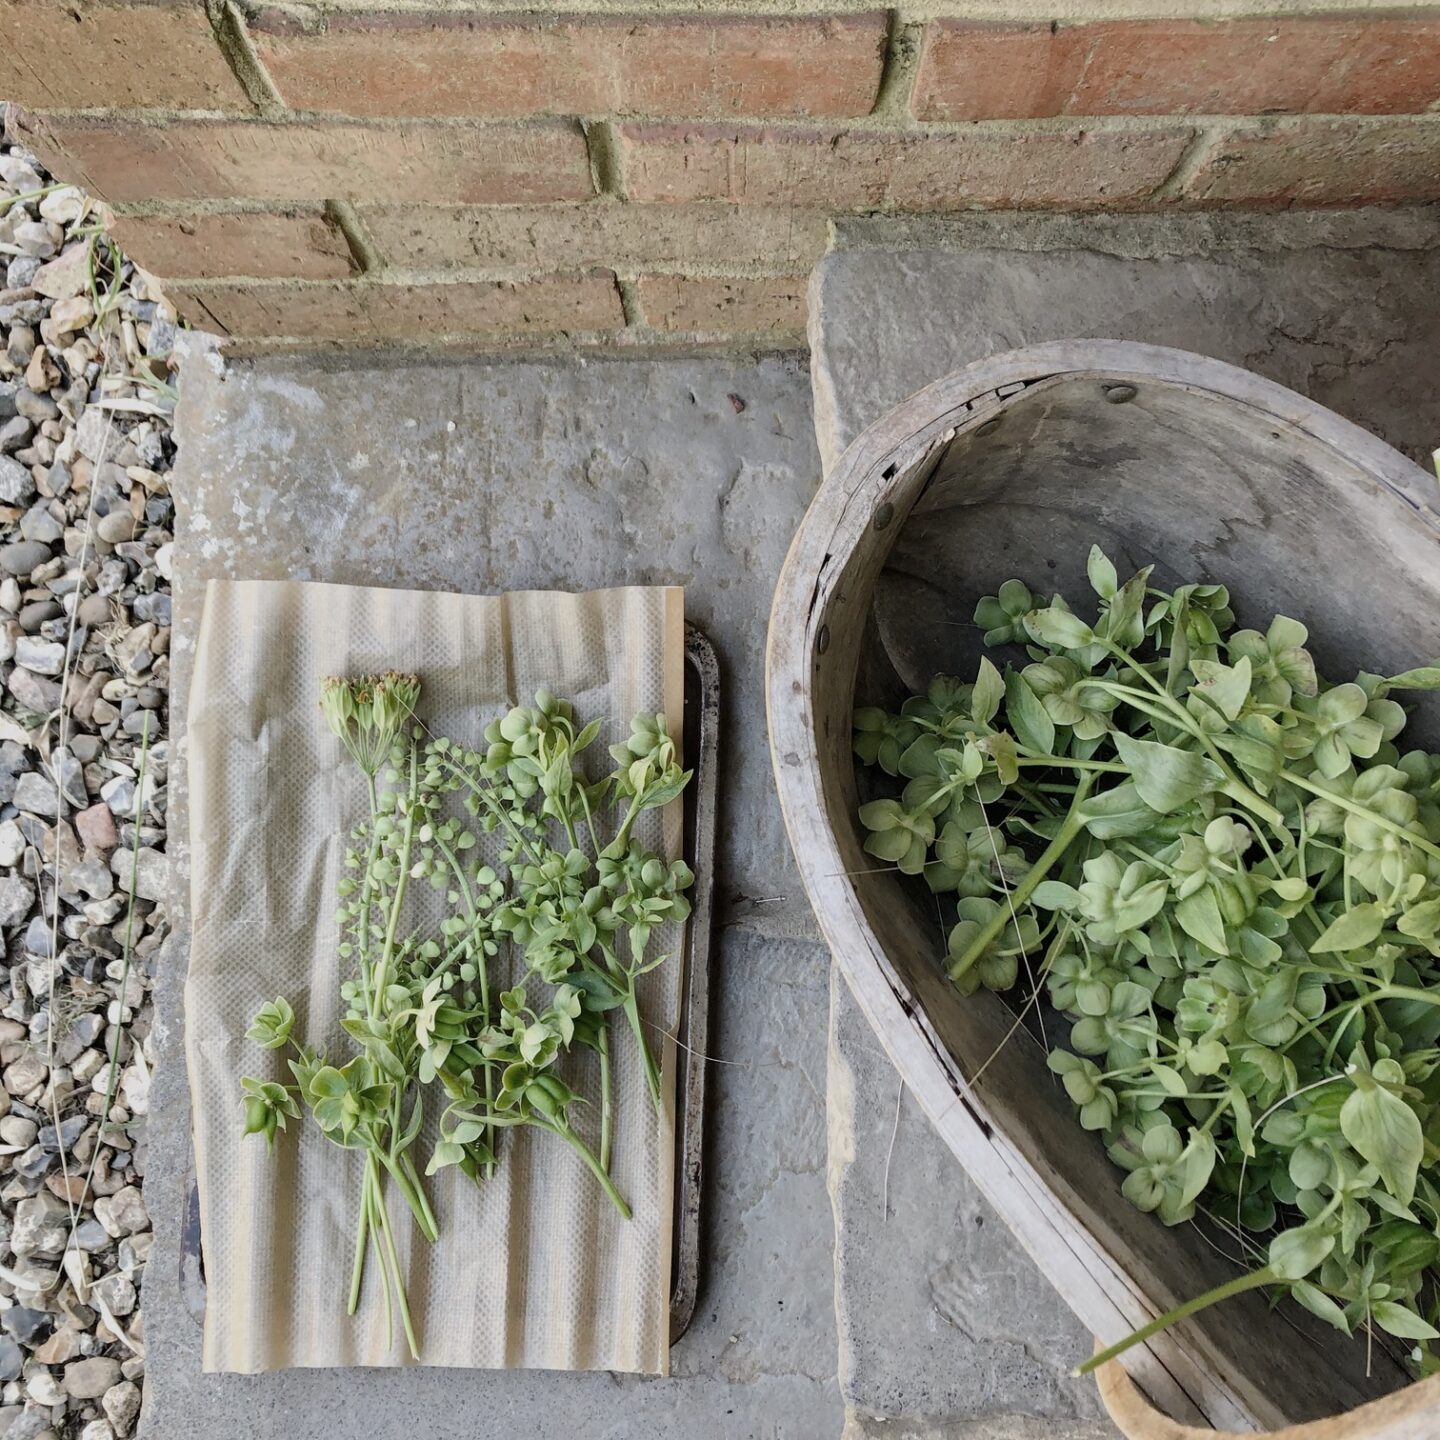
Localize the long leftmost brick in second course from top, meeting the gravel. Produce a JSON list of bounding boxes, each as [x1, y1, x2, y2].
[[12, 117, 595, 204]]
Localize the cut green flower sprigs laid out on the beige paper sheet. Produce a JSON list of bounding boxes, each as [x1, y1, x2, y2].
[[240, 674, 694, 1358]]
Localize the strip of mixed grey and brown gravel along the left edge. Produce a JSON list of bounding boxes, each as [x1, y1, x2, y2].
[[0, 122, 176, 1440]]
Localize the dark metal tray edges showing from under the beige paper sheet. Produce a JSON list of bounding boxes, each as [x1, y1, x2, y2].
[[180, 625, 720, 1345]]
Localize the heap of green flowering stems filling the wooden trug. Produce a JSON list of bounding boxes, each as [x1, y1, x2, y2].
[[855, 549, 1440, 1372]]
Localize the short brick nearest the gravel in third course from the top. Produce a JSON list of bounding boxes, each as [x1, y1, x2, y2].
[[111, 210, 354, 279]]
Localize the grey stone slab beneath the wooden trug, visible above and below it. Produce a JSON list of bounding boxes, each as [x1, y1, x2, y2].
[[811, 210, 1440, 1440]]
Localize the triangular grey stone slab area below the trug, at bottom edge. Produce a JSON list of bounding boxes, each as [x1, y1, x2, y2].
[[828, 971, 1113, 1440]]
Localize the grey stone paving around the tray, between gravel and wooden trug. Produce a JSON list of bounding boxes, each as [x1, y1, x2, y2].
[[143, 356, 842, 1440]]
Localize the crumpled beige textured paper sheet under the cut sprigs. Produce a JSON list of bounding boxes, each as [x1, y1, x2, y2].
[[186, 580, 684, 1374]]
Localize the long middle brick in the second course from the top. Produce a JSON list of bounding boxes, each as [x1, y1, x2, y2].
[[621, 125, 1191, 210]]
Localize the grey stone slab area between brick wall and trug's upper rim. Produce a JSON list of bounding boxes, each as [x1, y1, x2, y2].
[[811, 209, 1440, 465]]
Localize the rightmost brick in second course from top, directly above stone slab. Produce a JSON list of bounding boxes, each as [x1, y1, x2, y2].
[[1185, 117, 1440, 206]]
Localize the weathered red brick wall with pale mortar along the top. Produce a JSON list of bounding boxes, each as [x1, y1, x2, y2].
[[0, 0, 1440, 344]]
